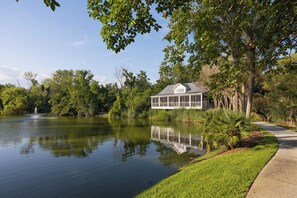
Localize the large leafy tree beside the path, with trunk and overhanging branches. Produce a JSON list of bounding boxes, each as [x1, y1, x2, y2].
[[88, 0, 296, 116]]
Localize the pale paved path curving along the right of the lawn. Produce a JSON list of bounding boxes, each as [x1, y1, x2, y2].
[[247, 122, 297, 198]]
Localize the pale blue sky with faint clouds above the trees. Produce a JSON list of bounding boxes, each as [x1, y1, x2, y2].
[[0, 0, 168, 87]]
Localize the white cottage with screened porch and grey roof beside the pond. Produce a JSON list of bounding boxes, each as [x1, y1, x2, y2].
[[151, 83, 209, 109]]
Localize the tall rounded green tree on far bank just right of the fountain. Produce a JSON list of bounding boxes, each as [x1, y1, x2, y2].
[[44, 70, 99, 116]]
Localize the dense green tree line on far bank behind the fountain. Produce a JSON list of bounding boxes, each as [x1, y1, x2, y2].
[[0, 70, 118, 116]]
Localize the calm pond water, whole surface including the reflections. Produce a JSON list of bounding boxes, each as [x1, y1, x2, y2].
[[0, 118, 203, 197]]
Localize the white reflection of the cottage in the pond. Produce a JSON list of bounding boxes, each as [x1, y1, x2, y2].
[[151, 126, 205, 155]]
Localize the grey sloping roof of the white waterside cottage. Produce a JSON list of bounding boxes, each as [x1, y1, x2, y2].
[[157, 83, 207, 96]]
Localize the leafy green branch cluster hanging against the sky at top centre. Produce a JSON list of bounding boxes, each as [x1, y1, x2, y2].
[[88, 0, 161, 52]]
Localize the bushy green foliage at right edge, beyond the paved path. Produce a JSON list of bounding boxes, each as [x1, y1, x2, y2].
[[254, 53, 297, 126]]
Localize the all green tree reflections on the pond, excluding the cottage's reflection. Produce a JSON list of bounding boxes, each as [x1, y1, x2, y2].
[[20, 117, 200, 166]]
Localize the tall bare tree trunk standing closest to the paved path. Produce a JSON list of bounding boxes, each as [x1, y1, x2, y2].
[[246, 31, 256, 117]]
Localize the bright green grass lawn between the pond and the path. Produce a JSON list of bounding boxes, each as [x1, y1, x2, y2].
[[137, 131, 278, 198]]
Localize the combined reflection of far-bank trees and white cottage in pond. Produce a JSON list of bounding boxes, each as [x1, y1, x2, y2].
[[20, 120, 205, 163]]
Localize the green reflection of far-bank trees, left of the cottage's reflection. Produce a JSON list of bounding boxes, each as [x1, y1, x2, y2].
[[20, 119, 150, 161]]
